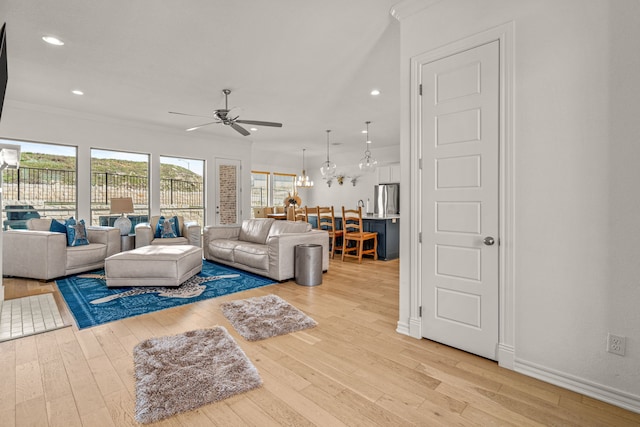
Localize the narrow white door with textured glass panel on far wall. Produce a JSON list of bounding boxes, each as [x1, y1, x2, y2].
[[215, 159, 242, 225]]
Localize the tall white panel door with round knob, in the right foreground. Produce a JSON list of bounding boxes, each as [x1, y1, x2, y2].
[[421, 41, 500, 360]]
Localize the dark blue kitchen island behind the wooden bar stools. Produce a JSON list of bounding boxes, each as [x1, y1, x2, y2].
[[309, 214, 400, 261]]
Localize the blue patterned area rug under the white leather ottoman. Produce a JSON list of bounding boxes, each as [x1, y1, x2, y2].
[[56, 260, 274, 329]]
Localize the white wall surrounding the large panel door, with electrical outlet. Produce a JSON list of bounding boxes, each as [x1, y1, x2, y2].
[[399, 0, 640, 411]]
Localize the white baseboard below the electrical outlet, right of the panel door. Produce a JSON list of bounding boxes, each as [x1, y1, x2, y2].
[[514, 359, 640, 414]]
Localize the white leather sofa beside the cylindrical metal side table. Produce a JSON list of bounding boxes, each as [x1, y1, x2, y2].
[[202, 218, 329, 281]]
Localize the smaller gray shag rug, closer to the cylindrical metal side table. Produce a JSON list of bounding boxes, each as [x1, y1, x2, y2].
[[221, 295, 317, 341]]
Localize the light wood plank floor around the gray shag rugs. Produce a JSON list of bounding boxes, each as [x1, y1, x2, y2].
[[0, 260, 640, 427]]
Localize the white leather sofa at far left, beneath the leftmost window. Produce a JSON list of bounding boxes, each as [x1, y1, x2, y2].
[[2, 218, 120, 280]]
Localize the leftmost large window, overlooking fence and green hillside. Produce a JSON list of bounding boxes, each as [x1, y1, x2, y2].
[[0, 139, 77, 230]]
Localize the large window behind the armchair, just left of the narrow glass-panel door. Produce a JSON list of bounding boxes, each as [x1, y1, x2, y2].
[[160, 156, 204, 225]]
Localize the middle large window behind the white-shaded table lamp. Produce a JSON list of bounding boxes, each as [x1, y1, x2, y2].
[[91, 149, 149, 233]]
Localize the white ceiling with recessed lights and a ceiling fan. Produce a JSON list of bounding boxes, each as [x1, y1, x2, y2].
[[0, 0, 400, 155]]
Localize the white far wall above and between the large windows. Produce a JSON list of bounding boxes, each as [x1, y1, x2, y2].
[[0, 100, 252, 226]]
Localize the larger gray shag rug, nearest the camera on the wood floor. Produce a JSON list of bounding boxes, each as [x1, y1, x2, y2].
[[133, 326, 262, 423]]
